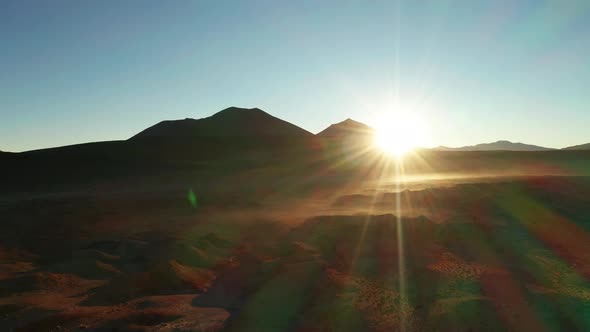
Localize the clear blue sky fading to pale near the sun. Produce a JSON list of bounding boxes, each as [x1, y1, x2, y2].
[[0, 0, 590, 151]]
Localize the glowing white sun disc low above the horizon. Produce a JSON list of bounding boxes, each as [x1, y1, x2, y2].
[[374, 113, 425, 158]]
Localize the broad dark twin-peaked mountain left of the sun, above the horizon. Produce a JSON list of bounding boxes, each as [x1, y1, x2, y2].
[[130, 107, 313, 140]]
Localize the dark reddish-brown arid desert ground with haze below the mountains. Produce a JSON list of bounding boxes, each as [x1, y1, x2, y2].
[[0, 127, 590, 331]]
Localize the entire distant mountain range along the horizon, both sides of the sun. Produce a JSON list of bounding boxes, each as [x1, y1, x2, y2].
[[0, 107, 590, 154]]
